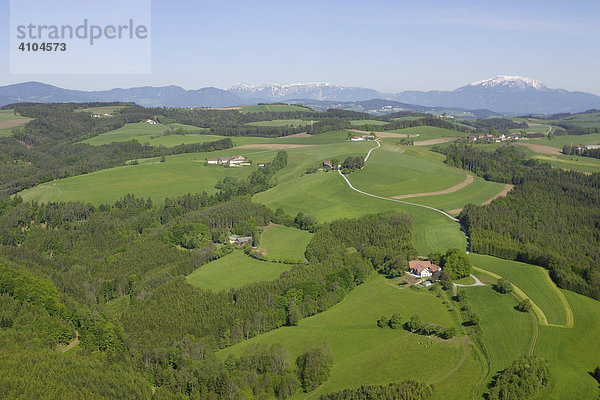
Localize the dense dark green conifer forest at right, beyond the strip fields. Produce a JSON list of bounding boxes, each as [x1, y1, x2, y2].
[[434, 145, 600, 299]]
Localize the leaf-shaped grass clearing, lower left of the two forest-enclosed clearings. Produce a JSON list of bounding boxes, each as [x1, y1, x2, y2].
[[186, 250, 291, 292]]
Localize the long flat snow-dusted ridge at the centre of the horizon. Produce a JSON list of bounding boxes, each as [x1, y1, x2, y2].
[[229, 82, 384, 101]]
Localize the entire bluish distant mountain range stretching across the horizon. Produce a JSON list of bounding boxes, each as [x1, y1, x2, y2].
[[0, 76, 600, 114]]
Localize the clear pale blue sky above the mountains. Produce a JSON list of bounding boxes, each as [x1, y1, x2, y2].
[[0, 0, 600, 94]]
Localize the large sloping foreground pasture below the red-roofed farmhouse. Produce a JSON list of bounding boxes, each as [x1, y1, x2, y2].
[[218, 274, 480, 398]]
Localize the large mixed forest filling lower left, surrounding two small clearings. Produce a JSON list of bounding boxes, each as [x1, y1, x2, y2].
[[0, 152, 414, 398]]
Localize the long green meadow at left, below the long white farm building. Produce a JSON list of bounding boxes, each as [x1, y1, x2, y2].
[[19, 149, 273, 205]]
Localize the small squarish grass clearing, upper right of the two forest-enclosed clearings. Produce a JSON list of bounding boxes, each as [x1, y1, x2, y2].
[[260, 225, 312, 262]]
